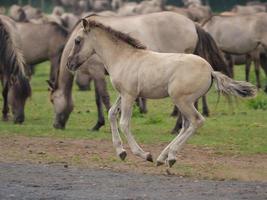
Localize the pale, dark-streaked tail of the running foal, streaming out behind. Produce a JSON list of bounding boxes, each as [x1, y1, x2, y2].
[[211, 71, 257, 98]]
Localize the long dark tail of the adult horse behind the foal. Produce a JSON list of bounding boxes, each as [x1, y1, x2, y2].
[[194, 24, 231, 76]]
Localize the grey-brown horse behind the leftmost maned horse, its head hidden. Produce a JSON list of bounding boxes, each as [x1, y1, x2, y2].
[[15, 22, 68, 81]]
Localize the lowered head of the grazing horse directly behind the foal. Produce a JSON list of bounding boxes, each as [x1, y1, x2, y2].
[[47, 81, 73, 129]]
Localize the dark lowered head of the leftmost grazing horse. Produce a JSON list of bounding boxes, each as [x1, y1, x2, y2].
[[8, 77, 31, 124]]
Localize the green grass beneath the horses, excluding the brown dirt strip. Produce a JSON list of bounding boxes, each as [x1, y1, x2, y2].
[[0, 62, 267, 154]]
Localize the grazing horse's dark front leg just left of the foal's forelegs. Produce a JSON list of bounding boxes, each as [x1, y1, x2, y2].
[[92, 81, 105, 131]]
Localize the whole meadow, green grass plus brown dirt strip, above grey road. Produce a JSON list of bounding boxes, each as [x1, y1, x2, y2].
[[0, 62, 267, 181]]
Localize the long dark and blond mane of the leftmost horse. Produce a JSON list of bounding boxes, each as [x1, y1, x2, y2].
[[0, 18, 31, 97]]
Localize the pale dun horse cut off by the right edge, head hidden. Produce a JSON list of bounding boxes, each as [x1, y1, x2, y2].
[[203, 13, 267, 88]]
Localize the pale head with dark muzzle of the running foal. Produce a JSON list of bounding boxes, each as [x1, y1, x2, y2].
[[67, 19, 94, 71]]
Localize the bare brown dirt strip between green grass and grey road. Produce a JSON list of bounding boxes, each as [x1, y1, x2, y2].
[[0, 136, 267, 182]]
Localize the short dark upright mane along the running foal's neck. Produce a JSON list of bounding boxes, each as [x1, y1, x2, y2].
[[88, 20, 147, 49]]
